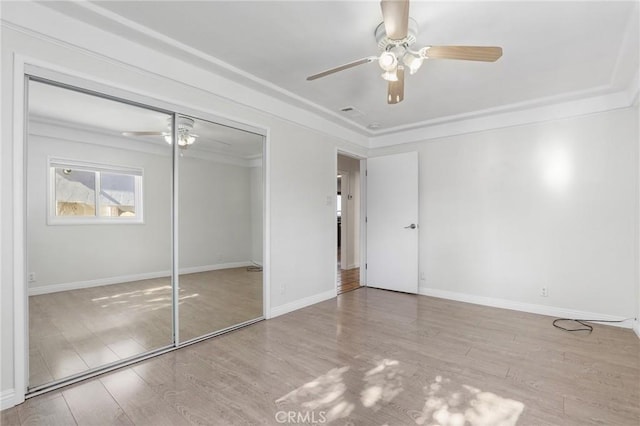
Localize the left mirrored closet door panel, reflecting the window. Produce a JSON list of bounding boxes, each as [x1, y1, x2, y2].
[[26, 80, 173, 389]]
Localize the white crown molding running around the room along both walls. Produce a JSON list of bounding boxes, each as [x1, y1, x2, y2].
[[3, 2, 639, 149]]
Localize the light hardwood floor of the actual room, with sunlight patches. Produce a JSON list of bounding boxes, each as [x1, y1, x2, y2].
[[2, 287, 640, 426]]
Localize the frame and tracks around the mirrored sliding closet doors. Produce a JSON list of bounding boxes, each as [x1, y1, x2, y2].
[[12, 60, 270, 404]]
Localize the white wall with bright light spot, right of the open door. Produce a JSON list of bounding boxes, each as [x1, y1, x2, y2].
[[372, 109, 639, 318]]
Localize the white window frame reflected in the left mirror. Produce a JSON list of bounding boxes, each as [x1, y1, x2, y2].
[[47, 157, 144, 225]]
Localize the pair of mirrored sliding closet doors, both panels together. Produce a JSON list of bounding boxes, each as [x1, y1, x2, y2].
[[25, 78, 264, 393]]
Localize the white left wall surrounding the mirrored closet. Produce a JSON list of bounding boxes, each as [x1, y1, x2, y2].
[[0, 2, 366, 406]]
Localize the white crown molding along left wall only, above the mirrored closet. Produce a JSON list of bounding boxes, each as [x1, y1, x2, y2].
[[0, 1, 368, 149]]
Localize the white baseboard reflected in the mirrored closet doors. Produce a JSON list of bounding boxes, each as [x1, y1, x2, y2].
[[29, 261, 253, 296]]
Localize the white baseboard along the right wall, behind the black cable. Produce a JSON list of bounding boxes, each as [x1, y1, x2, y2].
[[418, 287, 633, 328]]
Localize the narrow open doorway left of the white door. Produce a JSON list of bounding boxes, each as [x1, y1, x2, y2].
[[336, 153, 361, 294]]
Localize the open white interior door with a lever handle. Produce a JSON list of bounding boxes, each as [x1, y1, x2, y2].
[[367, 152, 418, 293]]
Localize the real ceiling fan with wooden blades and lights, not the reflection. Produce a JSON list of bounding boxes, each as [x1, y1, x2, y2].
[[307, 0, 502, 104]]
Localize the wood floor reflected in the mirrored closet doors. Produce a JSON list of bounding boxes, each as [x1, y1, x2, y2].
[[29, 268, 262, 387]]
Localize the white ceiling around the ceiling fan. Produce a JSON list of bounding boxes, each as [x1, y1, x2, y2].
[[44, 1, 639, 135]]
